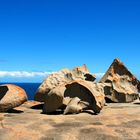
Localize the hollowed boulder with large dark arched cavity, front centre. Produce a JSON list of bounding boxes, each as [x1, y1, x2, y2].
[[43, 80, 105, 113]]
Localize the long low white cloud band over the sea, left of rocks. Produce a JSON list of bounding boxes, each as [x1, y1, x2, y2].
[[0, 71, 54, 78]]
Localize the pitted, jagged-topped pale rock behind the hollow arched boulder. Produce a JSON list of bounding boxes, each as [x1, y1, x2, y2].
[[34, 65, 96, 102]]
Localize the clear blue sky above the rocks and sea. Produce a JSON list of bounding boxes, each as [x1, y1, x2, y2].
[[0, 0, 140, 81]]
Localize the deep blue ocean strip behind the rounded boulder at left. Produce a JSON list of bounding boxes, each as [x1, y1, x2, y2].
[[0, 83, 41, 100]]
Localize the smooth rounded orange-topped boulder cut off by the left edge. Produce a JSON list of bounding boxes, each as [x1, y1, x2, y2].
[[0, 84, 27, 112]]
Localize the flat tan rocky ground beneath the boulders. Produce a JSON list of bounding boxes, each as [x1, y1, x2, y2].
[[0, 101, 140, 140]]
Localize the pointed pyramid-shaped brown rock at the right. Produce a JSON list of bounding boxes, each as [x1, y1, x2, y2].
[[100, 59, 139, 102]]
